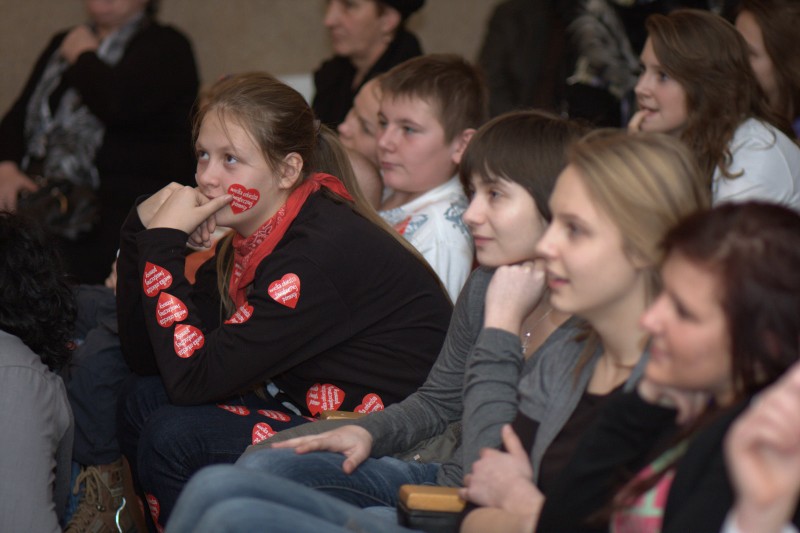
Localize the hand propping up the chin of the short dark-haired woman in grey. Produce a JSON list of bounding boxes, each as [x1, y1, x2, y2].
[[484, 261, 545, 334]]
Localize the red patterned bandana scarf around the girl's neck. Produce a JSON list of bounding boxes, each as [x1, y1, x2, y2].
[[228, 172, 353, 308]]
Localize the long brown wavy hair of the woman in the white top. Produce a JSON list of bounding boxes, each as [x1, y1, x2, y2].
[[645, 9, 794, 179]]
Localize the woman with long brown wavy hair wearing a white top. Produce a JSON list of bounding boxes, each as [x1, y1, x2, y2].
[[628, 9, 800, 210]]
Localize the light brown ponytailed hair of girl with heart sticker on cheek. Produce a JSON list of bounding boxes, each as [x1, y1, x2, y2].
[[194, 72, 438, 313]]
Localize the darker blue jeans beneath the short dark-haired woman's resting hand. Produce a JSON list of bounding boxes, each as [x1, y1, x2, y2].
[[236, 448, 439, 507]]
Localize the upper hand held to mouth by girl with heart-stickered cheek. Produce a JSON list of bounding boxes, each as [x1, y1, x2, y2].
[[147, 186, 231, 234]]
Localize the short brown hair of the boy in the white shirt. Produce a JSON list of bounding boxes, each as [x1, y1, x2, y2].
[[380, 54, 489, 143]]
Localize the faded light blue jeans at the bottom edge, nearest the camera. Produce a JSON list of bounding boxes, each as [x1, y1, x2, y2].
[[167, 465, 422, 533]]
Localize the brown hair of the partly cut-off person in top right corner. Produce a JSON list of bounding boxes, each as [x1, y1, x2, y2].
[[737, 0, 800, 125]]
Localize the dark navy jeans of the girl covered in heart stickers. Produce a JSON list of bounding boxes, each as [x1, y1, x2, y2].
[[117, 377, 308, 530]]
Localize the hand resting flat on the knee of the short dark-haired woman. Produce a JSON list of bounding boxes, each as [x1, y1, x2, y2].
[[272, 425, 372, 474]]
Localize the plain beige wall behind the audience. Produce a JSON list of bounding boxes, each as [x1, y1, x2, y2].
[[0, 0, 500, 113]]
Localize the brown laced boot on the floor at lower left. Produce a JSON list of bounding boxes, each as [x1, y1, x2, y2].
[[64, 459, 136, 533]]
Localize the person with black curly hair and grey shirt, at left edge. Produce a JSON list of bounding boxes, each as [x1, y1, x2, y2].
[[0, 213, 75, 531]]
